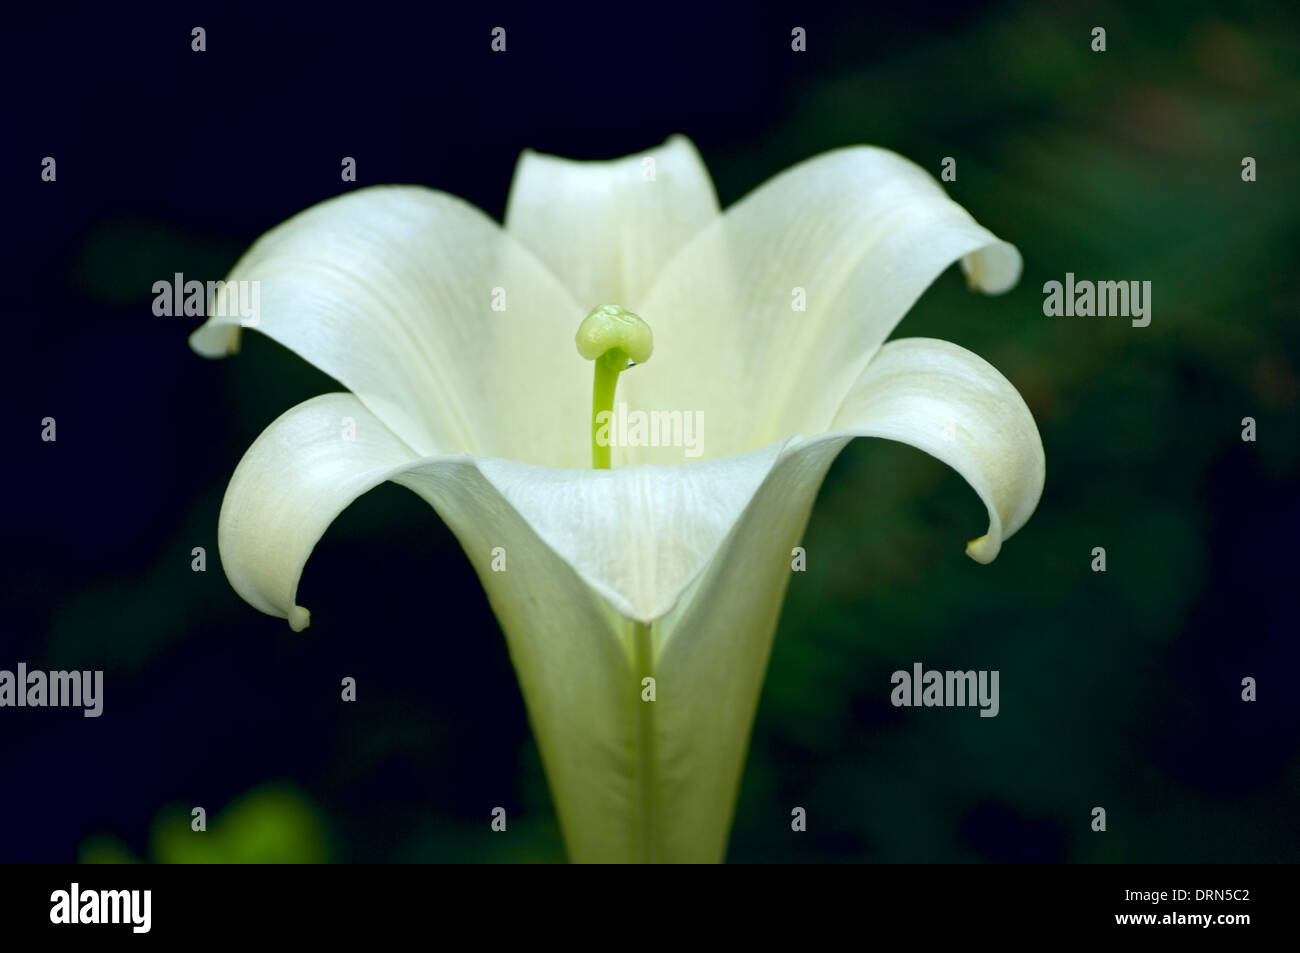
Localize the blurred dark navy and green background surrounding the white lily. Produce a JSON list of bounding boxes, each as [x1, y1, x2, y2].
[[0, 3, 1300, 862]]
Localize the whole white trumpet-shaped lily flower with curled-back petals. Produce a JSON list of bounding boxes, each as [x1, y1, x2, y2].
[[191, 137, 1044, 862]]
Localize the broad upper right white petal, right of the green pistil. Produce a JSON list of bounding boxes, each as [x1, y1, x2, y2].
[[625, 147, 1021, 463]]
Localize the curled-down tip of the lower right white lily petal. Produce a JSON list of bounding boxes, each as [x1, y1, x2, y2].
[[820, 338, 1047, 563]]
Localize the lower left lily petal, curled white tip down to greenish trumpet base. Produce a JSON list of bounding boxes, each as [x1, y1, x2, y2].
[[218, 394, 642, 861]]
